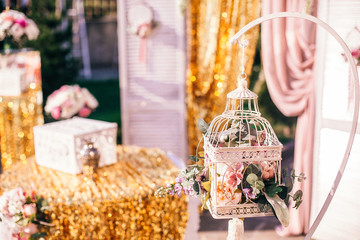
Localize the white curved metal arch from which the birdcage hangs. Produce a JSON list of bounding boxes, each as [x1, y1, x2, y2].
[[229, 12, 360, 240]]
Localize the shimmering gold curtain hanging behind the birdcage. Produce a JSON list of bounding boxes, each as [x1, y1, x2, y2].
[[186, 0, 261, 154]]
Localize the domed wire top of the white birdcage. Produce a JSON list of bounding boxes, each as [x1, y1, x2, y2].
[[205, 76, 282, 148]]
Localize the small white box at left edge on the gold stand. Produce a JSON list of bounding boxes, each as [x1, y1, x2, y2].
[[0, 68, 28, 96]]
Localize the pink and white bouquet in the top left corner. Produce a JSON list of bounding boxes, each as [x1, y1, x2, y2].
[[0, 10, 39, 47]]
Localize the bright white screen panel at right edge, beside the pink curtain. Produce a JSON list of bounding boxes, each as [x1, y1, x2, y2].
[[311, 0, 360, 240]]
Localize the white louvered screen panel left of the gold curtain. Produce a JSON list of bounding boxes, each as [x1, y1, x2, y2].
[[118, 0, 187, 159]]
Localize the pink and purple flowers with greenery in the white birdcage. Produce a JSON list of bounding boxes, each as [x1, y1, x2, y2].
[[155, 119, 306, 226]]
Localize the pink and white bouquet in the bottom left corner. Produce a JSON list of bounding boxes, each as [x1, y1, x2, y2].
[[0, 188, 51, 240]]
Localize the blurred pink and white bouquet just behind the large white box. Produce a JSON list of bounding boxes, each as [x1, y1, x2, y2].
[[45, 85, 99, 120]]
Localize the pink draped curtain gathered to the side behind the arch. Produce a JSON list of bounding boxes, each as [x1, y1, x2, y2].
[[261, 0, 316, 235]]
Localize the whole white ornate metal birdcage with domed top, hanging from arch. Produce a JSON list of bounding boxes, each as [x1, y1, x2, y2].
[[204, 39, 283, 218]]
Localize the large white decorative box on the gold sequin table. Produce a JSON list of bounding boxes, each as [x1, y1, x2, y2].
[[34, 117, 117, 174]]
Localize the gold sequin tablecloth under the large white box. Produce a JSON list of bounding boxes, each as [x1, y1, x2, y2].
[[0, 146, 188, 240]]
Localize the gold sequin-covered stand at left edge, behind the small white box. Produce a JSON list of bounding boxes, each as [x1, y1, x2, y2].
[[0, 51, 44, 170]]
